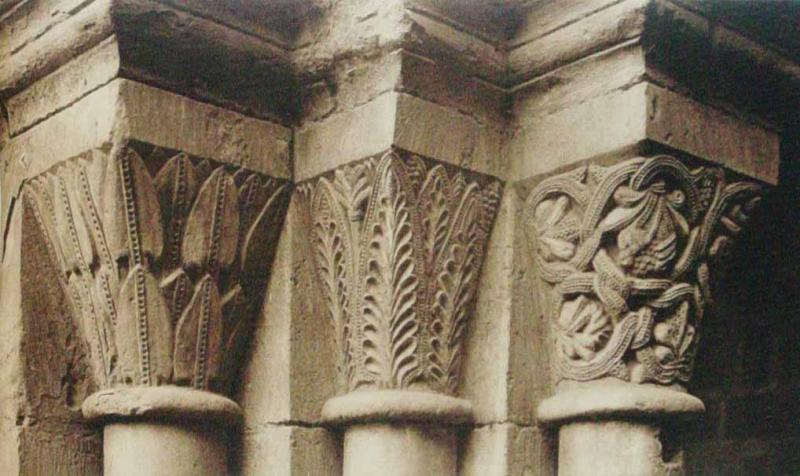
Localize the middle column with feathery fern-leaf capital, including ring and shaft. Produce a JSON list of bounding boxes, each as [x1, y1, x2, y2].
[[301, 152, 501, 476]]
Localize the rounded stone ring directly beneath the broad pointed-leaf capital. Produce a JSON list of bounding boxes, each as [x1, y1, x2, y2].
[[81, 385, 242, 424]]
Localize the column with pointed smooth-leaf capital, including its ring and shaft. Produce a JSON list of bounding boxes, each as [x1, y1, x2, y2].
[[21, 144, 290, 476]]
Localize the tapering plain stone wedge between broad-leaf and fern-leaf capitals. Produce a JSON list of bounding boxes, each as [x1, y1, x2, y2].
[[239, 194, 336, 424]]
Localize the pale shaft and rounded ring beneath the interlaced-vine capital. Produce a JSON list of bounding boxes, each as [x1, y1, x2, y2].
[[538, 382, 704, 476]]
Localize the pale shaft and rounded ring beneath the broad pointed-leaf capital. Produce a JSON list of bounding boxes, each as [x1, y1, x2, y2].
[[81, 385, 241, 476]]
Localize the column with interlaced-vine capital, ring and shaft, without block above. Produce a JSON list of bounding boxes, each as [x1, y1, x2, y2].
[[527, 155, 761, 475]]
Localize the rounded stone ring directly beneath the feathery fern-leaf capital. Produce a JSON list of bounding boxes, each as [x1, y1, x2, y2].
[[322, 390, 473, 426]]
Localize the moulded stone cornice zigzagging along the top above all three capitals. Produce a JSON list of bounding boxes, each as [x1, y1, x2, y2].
[[0, 0, 800, 135]]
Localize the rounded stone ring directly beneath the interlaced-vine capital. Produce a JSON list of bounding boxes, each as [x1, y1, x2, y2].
[[537, 383, 705, 426]]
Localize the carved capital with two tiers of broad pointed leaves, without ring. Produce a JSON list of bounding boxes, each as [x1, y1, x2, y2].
[[23, 147, 290, 393]]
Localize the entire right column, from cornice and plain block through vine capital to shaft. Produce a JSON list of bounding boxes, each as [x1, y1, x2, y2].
[[508, 1, 800, 475]]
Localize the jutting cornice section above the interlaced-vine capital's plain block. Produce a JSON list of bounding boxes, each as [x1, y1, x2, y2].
[[504, 0, 800, 127]]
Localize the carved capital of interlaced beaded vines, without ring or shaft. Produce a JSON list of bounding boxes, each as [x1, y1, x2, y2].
[[527, 156, 760, 384]]
